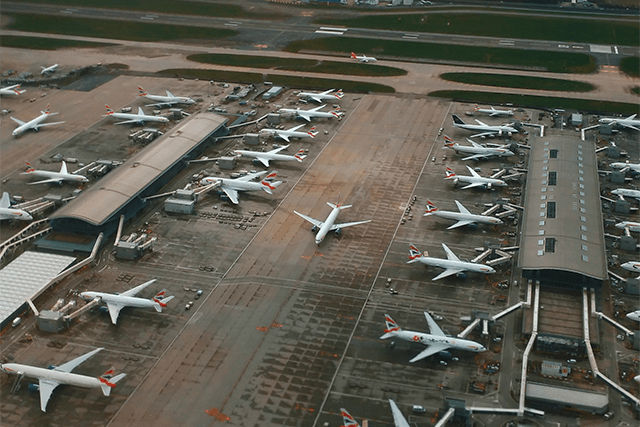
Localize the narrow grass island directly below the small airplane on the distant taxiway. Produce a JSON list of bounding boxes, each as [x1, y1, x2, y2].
[[187, 53, 407, 76]]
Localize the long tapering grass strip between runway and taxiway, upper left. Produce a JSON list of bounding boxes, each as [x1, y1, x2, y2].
[[3, 14, 237, 42]]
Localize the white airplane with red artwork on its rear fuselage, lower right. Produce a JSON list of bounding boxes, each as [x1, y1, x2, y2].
[[380, 311, 487, 363]]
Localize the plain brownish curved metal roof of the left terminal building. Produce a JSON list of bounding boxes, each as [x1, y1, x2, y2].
[[51, 112, 227, 225]]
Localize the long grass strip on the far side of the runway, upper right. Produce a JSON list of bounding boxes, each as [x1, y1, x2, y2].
[[314, 9, 640, 46]]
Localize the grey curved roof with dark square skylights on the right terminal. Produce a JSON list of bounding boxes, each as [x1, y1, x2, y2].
[[519, 135, 607, 280]]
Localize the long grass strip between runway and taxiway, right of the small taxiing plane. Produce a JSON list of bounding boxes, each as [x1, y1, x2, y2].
[[285, 37, 596, 73]]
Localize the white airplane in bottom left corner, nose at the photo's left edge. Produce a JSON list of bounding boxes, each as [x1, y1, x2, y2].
[[0, 348, 127, 412]]
